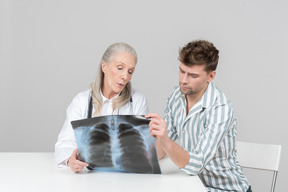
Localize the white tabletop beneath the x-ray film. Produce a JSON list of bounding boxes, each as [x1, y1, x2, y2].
[[0, 153, 206, 192]]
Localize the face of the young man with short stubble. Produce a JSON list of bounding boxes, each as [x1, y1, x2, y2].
[[179, 63, 216, 96]]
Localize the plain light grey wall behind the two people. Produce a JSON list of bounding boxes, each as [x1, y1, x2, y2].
[[0, 0, 288, 191]]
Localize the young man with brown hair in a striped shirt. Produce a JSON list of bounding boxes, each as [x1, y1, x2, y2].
[[146, 40, 251, 192]]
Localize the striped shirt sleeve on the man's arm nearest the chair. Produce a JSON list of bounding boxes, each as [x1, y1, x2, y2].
[[182, 104, 236, 175]]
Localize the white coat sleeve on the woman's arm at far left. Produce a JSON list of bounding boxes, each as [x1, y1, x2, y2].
[[55, 91, 88, 167]]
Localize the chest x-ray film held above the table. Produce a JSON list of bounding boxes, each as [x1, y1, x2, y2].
[[71, 115, 161, 174]]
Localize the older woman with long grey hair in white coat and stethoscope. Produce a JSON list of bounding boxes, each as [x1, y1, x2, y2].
[[55, 43, 148, 172]]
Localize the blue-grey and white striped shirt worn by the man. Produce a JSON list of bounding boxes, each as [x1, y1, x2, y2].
[[165, 83, 249, 192]]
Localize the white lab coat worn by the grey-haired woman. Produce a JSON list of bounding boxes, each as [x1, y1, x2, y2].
[[55, 89, 149, 166]]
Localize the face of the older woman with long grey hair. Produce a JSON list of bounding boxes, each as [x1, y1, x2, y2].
[[101, 52, 136, 99]]
